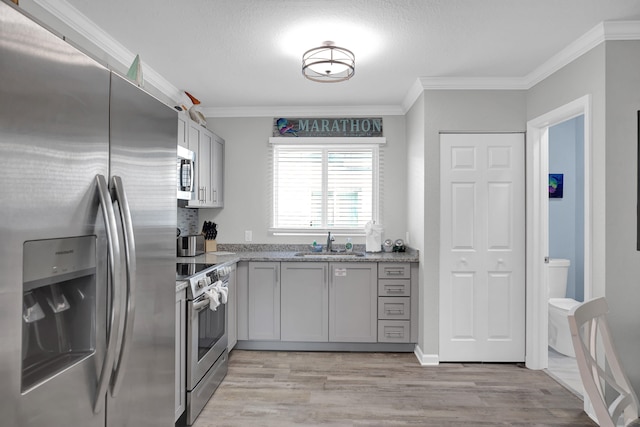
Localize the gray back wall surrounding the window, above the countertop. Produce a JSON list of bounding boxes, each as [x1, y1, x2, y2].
[[198, 116, 407, 244]]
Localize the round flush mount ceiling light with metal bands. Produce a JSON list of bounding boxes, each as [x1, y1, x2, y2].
[[302, 41, 356, 83]]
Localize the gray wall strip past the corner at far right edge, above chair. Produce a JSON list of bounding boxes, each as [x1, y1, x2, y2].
[[606, 41, 640, 392]]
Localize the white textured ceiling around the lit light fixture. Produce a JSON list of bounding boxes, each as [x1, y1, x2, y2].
[[62, 0, 640, 113]]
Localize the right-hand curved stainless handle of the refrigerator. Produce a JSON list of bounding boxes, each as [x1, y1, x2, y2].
[[111, 176, 136, 397]]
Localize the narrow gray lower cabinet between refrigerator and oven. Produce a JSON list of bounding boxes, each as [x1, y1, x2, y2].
[[175, 289, 187, 421]]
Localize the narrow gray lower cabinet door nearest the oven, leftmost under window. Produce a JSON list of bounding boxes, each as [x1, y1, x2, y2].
[[248, 262, 280, 341]]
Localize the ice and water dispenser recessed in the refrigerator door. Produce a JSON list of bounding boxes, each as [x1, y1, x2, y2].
[[21, 236, 97, 393]]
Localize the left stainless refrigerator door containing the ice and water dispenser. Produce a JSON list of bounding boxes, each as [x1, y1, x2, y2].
[[0, 2, 109, 427]]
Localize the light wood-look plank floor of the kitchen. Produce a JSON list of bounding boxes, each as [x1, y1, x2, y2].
[[194, 350, 596, 427]]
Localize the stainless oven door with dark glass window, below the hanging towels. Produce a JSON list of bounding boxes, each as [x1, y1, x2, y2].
[[187, 295, 227, 390]]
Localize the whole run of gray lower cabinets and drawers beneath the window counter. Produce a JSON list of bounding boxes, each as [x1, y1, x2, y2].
[[237, 261, 418, 351]]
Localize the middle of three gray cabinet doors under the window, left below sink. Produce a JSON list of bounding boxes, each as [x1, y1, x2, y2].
[[280, 262, 329, 342]]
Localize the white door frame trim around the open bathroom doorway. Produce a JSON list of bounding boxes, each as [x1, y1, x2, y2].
[[526, 95, 592, 369]]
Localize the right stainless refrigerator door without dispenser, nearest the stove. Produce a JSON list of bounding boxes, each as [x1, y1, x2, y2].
[[107, 74, 178, 426]]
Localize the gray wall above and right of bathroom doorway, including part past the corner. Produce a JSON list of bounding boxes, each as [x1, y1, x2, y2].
[[527, 41, 640, 391]]
